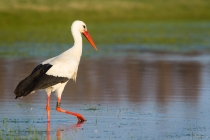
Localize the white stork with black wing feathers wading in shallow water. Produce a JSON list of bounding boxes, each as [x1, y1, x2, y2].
[[14, 20, 97, 122]]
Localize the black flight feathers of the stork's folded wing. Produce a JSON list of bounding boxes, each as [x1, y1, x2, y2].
[[14, 64, 69, 99]]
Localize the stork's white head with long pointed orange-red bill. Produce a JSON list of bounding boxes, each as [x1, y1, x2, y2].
[[71, 20, 97, 50]]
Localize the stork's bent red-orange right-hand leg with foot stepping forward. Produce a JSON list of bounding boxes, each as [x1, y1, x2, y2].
[[56, 98, 86, 122]]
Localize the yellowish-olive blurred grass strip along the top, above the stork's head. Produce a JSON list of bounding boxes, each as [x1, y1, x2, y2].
[[0, 0, 210, 23]]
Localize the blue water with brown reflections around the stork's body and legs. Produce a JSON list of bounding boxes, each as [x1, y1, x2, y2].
[[0, 53, 210, 140]]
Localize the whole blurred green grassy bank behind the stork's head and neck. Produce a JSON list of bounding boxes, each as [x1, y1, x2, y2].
[[0, 0, 210, 57]]
